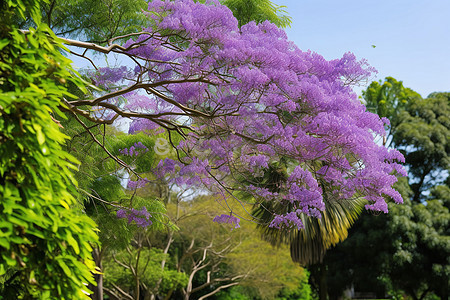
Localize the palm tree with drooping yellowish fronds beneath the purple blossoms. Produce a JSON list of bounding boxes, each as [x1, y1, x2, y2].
[[246, 159, 367, 300]]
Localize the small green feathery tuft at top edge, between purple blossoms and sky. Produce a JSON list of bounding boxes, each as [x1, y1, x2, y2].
[[221, 0, 292, 28]]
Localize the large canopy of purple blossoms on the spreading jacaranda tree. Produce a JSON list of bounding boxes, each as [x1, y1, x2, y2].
[[98, 0, 406, 228]]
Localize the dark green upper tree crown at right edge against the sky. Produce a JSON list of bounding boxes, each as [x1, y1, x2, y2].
[[393, 93, 450, 202]]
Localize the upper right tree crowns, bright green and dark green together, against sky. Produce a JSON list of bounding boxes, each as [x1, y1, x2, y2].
[[363, 77, 450, 202]]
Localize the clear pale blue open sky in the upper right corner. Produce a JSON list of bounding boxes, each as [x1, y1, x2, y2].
[[278, 0, 450, 97]]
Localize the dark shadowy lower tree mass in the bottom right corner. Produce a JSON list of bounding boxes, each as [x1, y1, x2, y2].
[[325, 182, 450, 299]]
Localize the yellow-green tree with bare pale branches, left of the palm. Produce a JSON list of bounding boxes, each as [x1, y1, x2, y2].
[[163, 196, 306, 299]]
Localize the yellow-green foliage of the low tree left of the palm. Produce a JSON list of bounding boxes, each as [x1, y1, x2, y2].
[[168, 196, 307, 299]]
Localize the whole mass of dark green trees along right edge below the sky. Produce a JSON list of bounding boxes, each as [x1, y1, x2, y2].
[[325, 78, 450, 299]]
